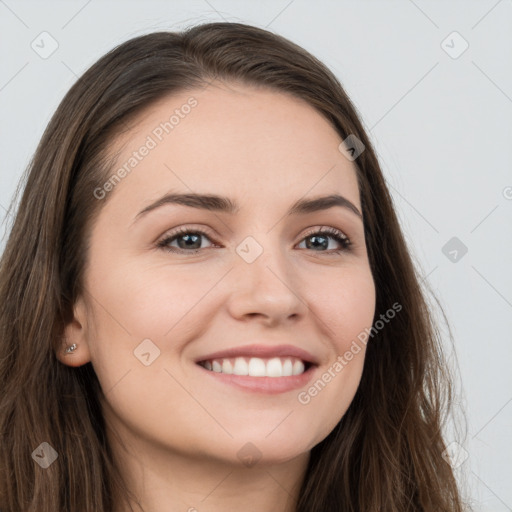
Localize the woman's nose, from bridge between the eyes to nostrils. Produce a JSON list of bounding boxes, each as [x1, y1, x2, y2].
[[227, 238, 308, 326]]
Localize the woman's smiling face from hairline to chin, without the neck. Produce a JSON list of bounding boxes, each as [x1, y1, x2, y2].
[[61, 84, 375, 464]]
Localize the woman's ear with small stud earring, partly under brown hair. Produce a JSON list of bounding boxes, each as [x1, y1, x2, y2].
[[56, 297, 91, 367]]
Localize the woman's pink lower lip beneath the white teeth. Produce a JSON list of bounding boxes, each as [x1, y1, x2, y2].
[[197, 365, 317, 395]]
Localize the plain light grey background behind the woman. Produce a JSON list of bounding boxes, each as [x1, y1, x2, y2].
[[0, 0, 512, 512]]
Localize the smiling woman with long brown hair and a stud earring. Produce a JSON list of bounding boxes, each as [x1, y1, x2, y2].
[[0, 23, 468, 512]]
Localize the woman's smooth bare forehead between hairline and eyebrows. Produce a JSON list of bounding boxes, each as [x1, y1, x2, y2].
[[101, 84, 358, 212]]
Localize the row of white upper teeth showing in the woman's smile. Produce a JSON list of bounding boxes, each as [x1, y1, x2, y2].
[[201, 357, 305, 377]]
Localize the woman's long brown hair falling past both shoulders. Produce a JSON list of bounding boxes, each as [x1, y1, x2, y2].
[[0, 23, 463, 512]]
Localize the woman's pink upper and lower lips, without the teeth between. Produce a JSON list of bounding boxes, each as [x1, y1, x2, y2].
[[195, 345, 318, 395]]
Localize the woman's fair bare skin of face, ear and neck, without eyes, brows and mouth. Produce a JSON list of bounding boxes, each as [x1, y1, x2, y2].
[[58, 83, 375, 512]]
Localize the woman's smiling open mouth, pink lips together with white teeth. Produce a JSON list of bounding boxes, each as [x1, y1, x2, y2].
[[196, 345, 318, 394]]
